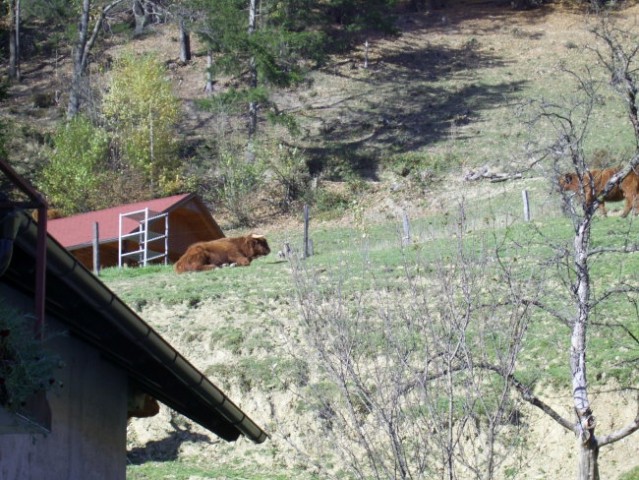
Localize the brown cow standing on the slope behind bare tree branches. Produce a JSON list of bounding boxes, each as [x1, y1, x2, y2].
[[559, 168, 639, 217]]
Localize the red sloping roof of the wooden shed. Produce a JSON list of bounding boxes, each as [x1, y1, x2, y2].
[[47, 193, 193, 248]]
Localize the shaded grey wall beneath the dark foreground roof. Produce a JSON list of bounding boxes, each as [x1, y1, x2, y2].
[[0, 286, 127, 480]]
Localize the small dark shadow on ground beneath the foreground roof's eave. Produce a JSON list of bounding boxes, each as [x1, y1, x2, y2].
[[127, 418, 212, 465]]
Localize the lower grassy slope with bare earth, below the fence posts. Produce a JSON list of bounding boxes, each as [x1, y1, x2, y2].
[[109, 174, 639, 479]]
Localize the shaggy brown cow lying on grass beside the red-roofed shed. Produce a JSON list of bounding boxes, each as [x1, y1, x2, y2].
[[173, 234, 271, 273]]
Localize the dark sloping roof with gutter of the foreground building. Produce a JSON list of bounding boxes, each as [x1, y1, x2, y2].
[[0, 211, 267, 443]]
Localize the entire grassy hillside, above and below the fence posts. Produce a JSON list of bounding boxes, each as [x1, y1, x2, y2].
[[0, 1, 639, 480]]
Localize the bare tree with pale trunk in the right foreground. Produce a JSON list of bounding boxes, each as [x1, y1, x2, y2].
[[527, 17, 639, 480]]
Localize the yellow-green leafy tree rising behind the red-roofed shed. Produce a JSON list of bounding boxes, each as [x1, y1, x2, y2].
[[103, 53, 184, 194]]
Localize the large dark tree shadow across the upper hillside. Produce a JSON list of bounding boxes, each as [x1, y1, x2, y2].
[[303, 39, 527, 177]]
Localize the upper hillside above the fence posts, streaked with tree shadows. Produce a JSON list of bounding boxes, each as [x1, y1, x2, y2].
[[0, 1, 634, 228]]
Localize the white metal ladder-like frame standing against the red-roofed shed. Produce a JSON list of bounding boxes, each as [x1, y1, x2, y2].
[[118, 208, 169, 267]]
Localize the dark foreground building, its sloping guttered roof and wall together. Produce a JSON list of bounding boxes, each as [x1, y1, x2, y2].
[[0, 179, 267, 480]]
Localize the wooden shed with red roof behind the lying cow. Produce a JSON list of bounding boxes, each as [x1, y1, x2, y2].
[[47, 193, 224, 269]]
